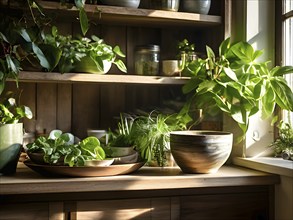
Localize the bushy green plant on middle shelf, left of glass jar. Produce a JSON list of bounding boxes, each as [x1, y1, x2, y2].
[[44, 27, 127, 73]]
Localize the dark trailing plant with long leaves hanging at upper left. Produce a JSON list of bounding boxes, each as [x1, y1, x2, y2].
[[0, 15, 60, 94]]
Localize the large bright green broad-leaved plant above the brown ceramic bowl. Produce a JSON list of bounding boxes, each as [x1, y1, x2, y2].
[[180, 38, 293, 140]]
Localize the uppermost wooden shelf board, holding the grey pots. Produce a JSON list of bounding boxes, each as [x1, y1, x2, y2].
[[35, 1, 222, 27]]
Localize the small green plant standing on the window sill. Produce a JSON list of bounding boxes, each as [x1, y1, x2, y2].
[[269, 121, 293, 159]]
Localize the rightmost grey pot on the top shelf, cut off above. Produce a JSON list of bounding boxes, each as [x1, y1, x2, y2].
[[181, 0, 211, 15]]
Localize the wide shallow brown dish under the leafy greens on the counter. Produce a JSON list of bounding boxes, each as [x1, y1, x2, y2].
[[23, 160, 145, 177]]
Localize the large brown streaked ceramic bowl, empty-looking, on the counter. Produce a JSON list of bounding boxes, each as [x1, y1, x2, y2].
[[170, 131, 233, 173]]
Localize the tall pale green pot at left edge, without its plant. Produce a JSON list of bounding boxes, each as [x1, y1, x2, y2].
[[0, 123, 23, 175]]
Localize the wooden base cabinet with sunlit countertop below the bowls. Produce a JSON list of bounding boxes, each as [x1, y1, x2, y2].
[[0, 166, 280, 220]]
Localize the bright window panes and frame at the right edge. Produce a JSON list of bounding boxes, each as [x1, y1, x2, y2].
[[276, 0, 293, 125]]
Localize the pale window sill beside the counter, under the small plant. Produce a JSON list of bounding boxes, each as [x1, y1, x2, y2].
[[233, 157, 293, 178]]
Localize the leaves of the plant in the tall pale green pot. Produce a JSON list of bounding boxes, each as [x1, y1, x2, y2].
[[0, 91, 33, 125]]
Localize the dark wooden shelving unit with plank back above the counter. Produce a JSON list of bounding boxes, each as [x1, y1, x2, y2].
[[2, 0, 231, 138]]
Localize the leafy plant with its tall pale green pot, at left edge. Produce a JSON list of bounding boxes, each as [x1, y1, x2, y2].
[[0, 92, 33, 175]]
